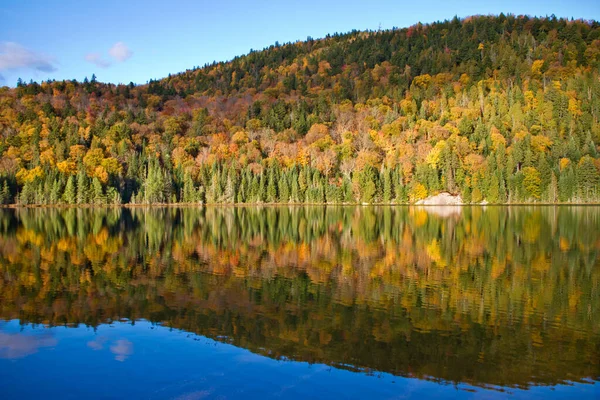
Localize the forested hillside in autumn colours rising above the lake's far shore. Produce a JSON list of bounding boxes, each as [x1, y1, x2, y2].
[[0, 15, 600, 205]]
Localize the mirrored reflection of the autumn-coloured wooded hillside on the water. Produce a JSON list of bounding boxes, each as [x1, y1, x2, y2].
[[0, 207, 600, 385]]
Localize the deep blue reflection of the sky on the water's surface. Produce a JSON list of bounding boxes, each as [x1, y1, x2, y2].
[[0, 320, 600, 399]]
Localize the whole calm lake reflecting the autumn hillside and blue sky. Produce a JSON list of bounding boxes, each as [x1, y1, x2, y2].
[[0, 206, 600, 399]]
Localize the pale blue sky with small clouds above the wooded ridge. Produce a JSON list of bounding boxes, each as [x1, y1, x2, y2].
[[0, 0, 600, 86]]
